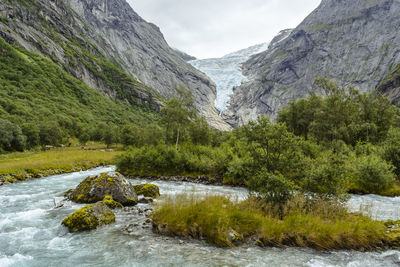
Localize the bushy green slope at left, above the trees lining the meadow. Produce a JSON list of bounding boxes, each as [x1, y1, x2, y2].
[[0, 37, 157, 136]]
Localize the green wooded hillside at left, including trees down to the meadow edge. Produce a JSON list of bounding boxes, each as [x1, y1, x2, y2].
[[0, 37, 159, 153]]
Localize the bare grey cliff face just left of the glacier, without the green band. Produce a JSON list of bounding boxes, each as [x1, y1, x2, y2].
[[66, 0, 229, 129]]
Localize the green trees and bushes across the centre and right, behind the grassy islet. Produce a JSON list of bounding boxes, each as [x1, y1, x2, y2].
[[117, 79, 400, 203]]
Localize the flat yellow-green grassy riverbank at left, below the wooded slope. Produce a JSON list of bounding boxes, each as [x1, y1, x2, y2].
[[0, 146, 121, 186]]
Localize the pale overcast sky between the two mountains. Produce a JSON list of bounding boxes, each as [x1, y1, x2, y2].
[[128, 0, 321, 58]]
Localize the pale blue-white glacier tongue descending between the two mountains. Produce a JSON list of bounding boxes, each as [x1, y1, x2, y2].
[[189, 30, 291, 111]]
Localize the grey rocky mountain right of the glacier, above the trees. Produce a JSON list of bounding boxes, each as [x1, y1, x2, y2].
[[223, 0, 400, 126]]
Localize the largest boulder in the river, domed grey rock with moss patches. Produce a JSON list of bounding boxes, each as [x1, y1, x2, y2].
[[69, 172, 138, 206]]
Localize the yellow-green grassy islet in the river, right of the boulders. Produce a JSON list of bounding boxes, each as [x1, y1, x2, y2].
[[152, 195, 387, 250]]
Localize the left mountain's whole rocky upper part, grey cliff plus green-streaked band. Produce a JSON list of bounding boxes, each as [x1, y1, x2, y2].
[[0, 0, 227, 129]]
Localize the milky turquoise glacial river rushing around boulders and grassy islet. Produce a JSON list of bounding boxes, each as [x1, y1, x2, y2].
[[0, 167, 400, 267]]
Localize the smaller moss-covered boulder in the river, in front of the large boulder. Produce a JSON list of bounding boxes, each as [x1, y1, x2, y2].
[[62, 201, 115, 233]]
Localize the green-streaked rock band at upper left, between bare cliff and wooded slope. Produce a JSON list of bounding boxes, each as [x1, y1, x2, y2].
[[0, 0, 161, 110]]
